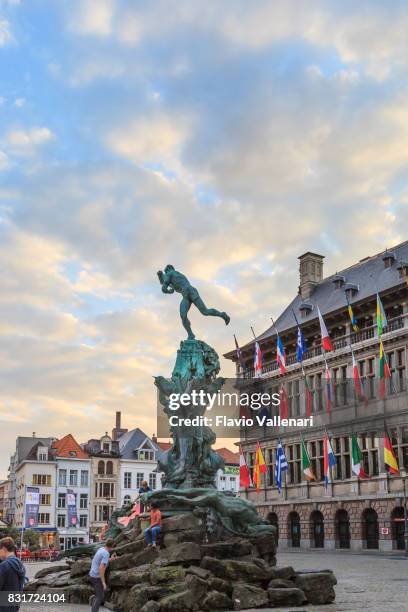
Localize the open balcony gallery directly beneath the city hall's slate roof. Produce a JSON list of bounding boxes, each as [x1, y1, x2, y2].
[[238, 313, 408, 380]]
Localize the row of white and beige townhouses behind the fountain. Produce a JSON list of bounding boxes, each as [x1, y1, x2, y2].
[[0, 412, 239, 550]]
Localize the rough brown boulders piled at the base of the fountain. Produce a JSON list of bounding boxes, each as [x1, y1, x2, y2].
[[26, 512, 337, 612]]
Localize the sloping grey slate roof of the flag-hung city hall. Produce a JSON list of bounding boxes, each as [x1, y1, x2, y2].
[[225, 241, 408, 358]]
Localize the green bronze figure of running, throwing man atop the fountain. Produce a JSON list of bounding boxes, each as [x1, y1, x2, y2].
[[157, 264, 230, 340]]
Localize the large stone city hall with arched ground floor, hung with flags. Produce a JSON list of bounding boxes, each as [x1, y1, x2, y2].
[[225, 242, 408, 551]]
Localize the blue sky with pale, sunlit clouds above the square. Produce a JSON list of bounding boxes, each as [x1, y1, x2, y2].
[[0, 0, 408, 476]]
